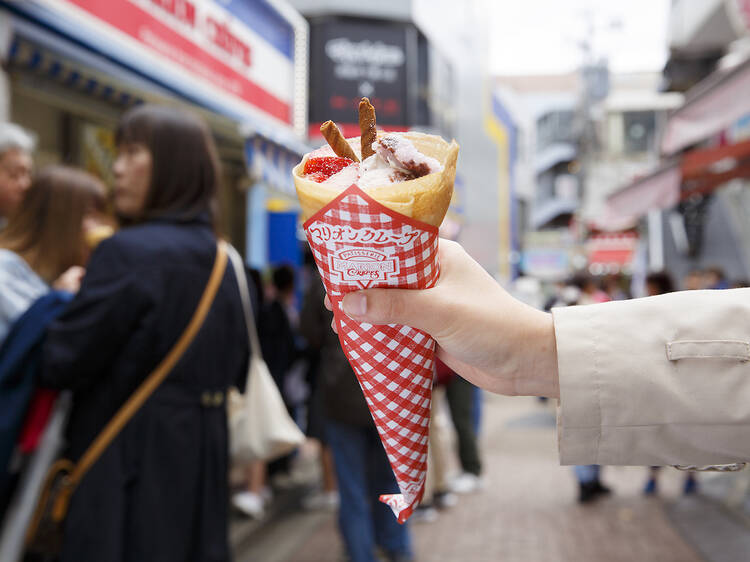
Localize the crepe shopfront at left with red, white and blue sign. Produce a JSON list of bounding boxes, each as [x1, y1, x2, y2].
[[0, 0, 307, 258]]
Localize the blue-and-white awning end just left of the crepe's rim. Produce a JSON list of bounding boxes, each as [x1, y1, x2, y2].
[[245, 134, 310, 199]]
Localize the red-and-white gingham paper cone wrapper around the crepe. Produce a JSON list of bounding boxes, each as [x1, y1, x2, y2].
[[304, 185, 439, 523]]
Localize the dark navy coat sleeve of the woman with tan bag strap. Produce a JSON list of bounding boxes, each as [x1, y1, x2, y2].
[[41, 237, 149, 390]]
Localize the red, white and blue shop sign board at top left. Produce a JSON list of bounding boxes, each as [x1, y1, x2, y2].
[[21, 0, 295, 125]]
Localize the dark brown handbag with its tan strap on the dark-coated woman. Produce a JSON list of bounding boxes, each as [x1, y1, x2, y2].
[[26, 238, 228, 556]]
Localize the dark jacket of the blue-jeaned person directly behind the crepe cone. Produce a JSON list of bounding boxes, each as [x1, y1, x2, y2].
[[300, 280, 374, 428]]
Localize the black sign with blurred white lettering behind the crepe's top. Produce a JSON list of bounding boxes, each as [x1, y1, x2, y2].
[[310, 21, 416, 136]]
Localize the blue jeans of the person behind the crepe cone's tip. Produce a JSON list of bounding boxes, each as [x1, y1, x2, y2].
[[326, 420, 412, 562]]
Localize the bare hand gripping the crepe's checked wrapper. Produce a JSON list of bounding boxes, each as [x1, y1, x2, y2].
[[327, 240, 560, 398]]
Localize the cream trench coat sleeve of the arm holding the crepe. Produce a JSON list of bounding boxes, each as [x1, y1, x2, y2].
[[552, 289, 750, 465]]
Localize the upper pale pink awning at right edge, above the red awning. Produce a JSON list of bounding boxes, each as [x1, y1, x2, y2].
[[661, 59, 750, 155]]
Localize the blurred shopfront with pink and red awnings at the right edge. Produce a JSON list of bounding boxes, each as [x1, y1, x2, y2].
[[607, 60, 750, 279]]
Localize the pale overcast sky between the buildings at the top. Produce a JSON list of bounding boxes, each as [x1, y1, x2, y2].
[[486, 0, 669, 75]]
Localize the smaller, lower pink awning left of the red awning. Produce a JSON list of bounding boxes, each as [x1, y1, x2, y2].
[[598, 161, 682, 226]]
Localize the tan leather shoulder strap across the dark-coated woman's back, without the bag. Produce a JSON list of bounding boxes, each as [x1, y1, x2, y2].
[[68, 241, 227, 488]]
